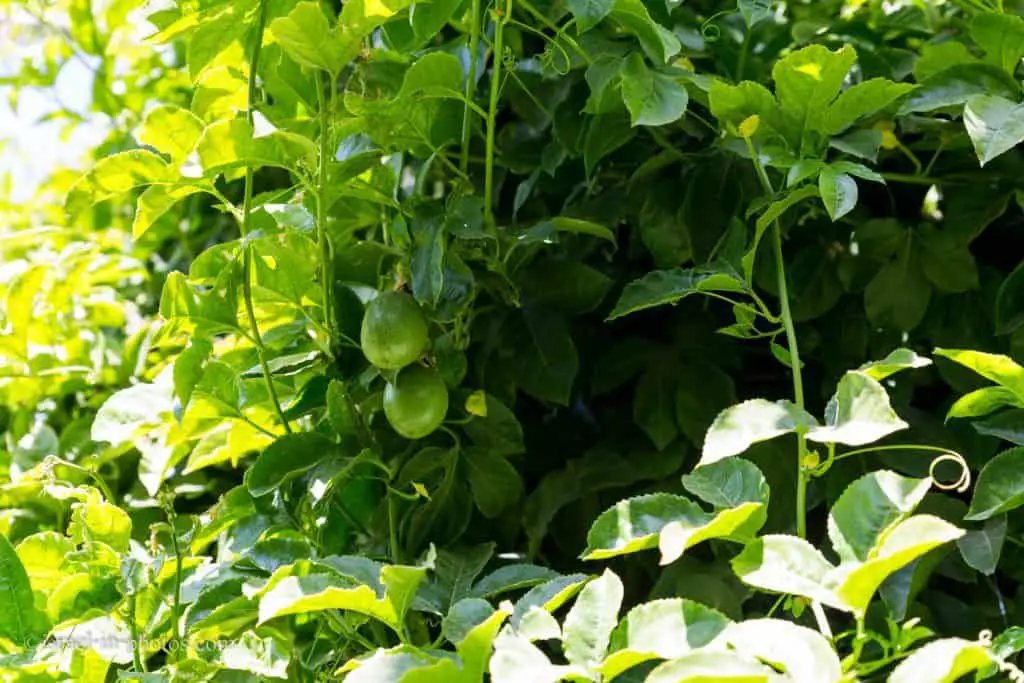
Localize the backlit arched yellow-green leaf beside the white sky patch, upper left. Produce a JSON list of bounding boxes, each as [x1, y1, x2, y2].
[[65, 150, 178, 214]]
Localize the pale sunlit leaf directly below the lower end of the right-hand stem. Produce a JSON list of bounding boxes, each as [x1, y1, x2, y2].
[[732, 535, 850, 611]]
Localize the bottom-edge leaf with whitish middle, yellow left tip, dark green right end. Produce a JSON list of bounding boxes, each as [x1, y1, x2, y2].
[[599, 598, 729, 680]]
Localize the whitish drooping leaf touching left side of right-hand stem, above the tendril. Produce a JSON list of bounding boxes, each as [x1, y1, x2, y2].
[[697, 398, 818, 467]]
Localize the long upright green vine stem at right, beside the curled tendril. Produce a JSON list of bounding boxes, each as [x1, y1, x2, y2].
[[743, 135, 810, 539]]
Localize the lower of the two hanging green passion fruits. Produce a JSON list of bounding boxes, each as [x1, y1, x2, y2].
[[384, 366, 447, 438]]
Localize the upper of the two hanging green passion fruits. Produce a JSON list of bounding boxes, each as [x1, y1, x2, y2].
[[359, 292, 427, 370]]
